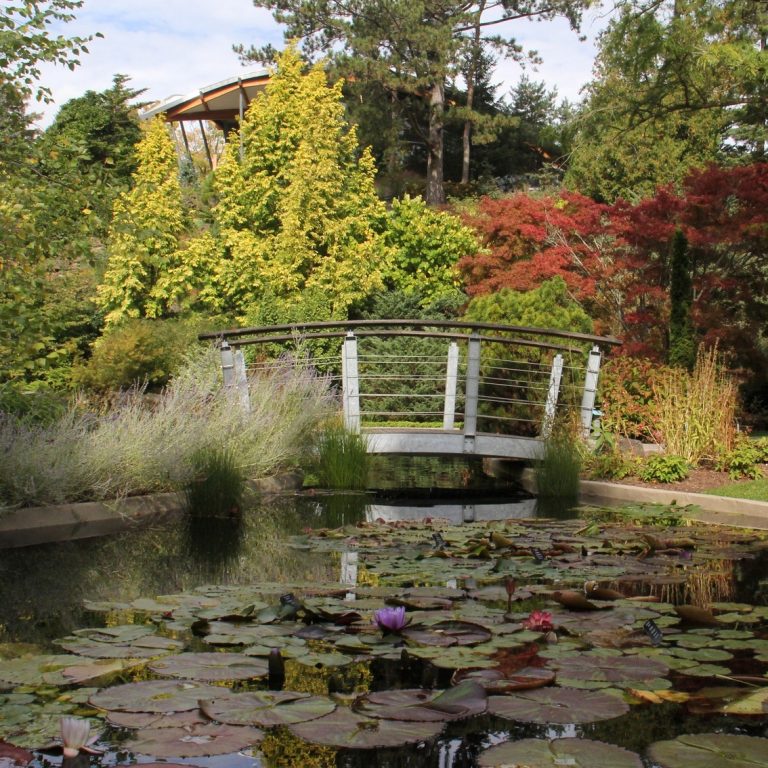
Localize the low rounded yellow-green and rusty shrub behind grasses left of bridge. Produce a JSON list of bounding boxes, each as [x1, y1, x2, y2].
[[73, 319, 205, 392]]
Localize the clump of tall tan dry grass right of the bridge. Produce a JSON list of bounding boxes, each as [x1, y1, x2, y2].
[[654, 347, 738, 465]]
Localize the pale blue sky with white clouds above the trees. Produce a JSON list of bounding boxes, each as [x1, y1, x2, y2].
[[31, 0, 605, 127]]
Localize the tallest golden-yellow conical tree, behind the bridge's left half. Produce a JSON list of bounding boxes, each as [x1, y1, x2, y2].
[[198, 48, 386, 319]]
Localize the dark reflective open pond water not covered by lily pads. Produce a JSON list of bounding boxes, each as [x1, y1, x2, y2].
[[0, 493, 765, 768]]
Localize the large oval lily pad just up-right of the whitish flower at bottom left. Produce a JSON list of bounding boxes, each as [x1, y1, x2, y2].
[[89, 680, 221, 713]]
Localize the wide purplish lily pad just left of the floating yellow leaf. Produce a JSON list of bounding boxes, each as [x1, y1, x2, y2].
[[488, 688, 629, 725]]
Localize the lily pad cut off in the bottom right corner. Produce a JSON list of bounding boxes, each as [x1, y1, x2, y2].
[[648, 733, 768, 768]]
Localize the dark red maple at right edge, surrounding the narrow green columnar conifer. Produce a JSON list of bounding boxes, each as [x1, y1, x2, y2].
[[611, 163, 768, 367]]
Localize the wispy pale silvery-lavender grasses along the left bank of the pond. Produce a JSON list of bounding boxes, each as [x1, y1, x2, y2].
[[0, 352, 333, 506]]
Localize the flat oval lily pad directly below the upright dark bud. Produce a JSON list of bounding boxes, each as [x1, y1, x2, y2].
[[200, 691, 336, 727]]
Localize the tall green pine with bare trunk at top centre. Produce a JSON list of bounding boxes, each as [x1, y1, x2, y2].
[[243, 0, 587, 205]]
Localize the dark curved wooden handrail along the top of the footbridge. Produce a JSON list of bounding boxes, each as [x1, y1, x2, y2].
[[198, 320, 622, 351]]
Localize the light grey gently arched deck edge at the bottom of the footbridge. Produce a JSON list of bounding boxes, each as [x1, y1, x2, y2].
[[362, 427, 544, 459]]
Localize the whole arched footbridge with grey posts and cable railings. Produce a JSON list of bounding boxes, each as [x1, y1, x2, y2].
[[200, 320, 621, 459]]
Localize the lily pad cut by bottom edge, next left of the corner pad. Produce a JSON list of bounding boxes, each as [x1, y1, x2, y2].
[[477, 739, 643, 768]]
